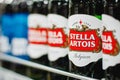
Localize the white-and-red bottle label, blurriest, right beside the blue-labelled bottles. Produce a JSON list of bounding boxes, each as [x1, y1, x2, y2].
[[27, 14, 48, 58]]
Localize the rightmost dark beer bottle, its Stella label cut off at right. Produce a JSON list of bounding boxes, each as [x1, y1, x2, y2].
[[102, 0, 120, 80]]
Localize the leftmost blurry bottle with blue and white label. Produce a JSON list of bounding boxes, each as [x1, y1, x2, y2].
[[1, 4, 13, 69]]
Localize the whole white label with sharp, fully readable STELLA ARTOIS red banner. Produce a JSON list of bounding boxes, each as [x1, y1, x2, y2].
[[68, 14, 102, 67]]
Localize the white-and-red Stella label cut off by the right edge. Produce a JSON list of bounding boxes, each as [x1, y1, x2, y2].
[[102, 14, 120, 69]]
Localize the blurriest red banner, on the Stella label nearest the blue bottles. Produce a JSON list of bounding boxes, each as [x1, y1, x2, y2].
[[28, 28, 48, 44]]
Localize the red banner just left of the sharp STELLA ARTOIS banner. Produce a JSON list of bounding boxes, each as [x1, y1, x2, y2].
[[48, 28, 68, 47]]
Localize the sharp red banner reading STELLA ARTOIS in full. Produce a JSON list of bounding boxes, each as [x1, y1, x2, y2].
[[69, 29, 102, 52]]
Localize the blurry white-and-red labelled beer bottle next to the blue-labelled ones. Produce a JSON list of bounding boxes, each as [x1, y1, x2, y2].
[[28, 1, 49, 80]]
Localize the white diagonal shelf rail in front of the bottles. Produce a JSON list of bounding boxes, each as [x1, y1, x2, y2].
[[0, 53, 96, 80]]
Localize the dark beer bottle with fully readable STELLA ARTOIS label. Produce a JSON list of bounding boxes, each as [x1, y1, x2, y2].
[[68, 0, 102, 80]]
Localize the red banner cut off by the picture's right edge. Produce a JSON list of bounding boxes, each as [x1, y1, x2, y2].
[[102, 31, 119, 55]]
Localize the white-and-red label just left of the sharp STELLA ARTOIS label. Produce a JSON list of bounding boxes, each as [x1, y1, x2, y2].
[[48, 14, 68, 61]]
